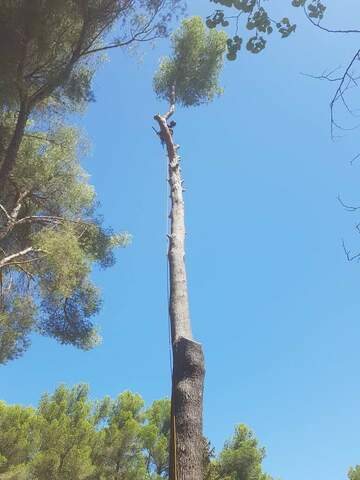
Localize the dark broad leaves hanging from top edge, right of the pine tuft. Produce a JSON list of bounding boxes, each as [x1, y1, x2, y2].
[[206, 0, 326, 60]]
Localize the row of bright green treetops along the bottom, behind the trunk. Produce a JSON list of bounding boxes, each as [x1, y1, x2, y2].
[[0, 385, 272, 480]]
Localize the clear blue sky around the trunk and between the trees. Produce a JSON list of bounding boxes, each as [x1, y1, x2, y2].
[[0, 0, 360, 480]]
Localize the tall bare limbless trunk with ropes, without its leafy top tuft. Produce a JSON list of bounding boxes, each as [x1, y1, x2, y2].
[[154, 105, 205, 480]]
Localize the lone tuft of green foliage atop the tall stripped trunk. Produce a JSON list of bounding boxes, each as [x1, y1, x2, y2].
[[154, 17, 227, 107]]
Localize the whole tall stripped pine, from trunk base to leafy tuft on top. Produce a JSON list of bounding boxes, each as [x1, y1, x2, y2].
[[154, 17, 226, 480]]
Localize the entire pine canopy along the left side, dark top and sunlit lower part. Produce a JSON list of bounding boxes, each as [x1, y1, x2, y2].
[[0, 0, 183, 364]]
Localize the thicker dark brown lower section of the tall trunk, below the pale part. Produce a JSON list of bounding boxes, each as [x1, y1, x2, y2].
[[170, 337, 205, 480]]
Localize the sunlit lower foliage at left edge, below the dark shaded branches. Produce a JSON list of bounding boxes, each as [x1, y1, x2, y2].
[[0, 127, 127, 363]]
